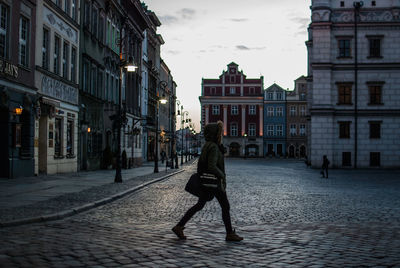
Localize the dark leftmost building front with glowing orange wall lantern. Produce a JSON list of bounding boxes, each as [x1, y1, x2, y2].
[[0, 0, 38, 178]]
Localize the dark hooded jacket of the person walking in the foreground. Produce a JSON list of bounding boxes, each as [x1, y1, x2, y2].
[[197, 122, 226, 190]]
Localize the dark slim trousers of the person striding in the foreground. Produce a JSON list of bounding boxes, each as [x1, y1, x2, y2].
[[178, 190, 232, 234]]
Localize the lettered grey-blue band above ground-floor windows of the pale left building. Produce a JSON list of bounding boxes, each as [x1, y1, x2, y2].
[[41, 76, 78, 104]]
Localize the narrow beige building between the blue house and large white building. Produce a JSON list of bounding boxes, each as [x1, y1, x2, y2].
[[286, 76, 308, 158]]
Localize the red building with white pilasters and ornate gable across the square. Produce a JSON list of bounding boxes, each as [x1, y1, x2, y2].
[[199, 62, 264, 157]]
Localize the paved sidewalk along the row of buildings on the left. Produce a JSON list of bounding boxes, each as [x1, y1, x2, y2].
[[0, 160, 194, 226]]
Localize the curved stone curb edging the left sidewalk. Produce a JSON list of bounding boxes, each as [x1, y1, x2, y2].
[[0, 169, 185, 228]]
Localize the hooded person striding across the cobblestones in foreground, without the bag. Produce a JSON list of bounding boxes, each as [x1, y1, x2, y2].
[[172, 121, 243, 241]]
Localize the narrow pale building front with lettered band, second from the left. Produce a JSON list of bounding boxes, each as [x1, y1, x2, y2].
[[34, 0, 80, 174]]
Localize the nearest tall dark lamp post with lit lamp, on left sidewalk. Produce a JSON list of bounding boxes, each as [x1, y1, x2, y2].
[[112, 18, 137, 183]]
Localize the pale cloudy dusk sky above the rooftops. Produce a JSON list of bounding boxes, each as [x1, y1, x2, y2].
[[144, 0, 311, 131]]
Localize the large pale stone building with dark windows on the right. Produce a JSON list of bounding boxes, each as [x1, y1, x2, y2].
[[306, 0, 400, 168]]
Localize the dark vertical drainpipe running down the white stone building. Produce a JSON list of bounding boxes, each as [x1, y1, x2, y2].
[[353, 1, 363, 169]]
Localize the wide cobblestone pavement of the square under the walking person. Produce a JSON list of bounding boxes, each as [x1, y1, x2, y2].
[[0, 159, 400, 267]]
